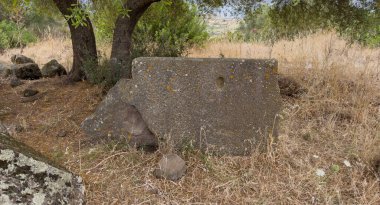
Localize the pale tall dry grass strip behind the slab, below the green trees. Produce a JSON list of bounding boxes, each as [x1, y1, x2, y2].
[[189, 33, 380, 73]]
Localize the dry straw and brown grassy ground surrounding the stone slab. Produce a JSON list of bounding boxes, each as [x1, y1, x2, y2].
[[0, 34, 380, 204]]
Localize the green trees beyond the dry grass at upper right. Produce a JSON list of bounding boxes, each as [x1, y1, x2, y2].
[[238, 0, 380, 46]]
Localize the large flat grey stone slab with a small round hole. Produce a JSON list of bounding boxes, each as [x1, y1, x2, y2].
[[86, 58, 281, 155]]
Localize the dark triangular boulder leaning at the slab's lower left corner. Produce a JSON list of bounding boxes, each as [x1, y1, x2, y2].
[[81, 96, 158, 152]]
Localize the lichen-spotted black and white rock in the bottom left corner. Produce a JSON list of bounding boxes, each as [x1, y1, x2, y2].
[[0, 123, 85, 205]]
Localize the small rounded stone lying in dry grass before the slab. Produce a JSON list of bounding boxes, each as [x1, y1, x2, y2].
[[153, 154, 186, 181]]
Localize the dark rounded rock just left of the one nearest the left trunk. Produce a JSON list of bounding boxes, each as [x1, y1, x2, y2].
[[11, 63, 42, 80]]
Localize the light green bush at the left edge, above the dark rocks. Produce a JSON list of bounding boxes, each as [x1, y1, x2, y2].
[[0, 20, 37, 49]]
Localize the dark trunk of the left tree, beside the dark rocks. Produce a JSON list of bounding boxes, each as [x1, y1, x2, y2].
[[54, 0, 97, 81]]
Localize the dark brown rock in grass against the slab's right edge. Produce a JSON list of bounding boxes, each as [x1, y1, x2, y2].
[[278, 75, 307, 98]]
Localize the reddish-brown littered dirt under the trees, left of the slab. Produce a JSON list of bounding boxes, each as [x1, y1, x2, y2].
[[0, 78, 101, 158]]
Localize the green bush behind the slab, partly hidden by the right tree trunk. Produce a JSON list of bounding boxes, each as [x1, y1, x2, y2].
[[94, 0, 208, 58]]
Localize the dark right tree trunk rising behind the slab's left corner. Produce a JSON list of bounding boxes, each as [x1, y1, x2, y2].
[[111, 0, 160, 78]]
